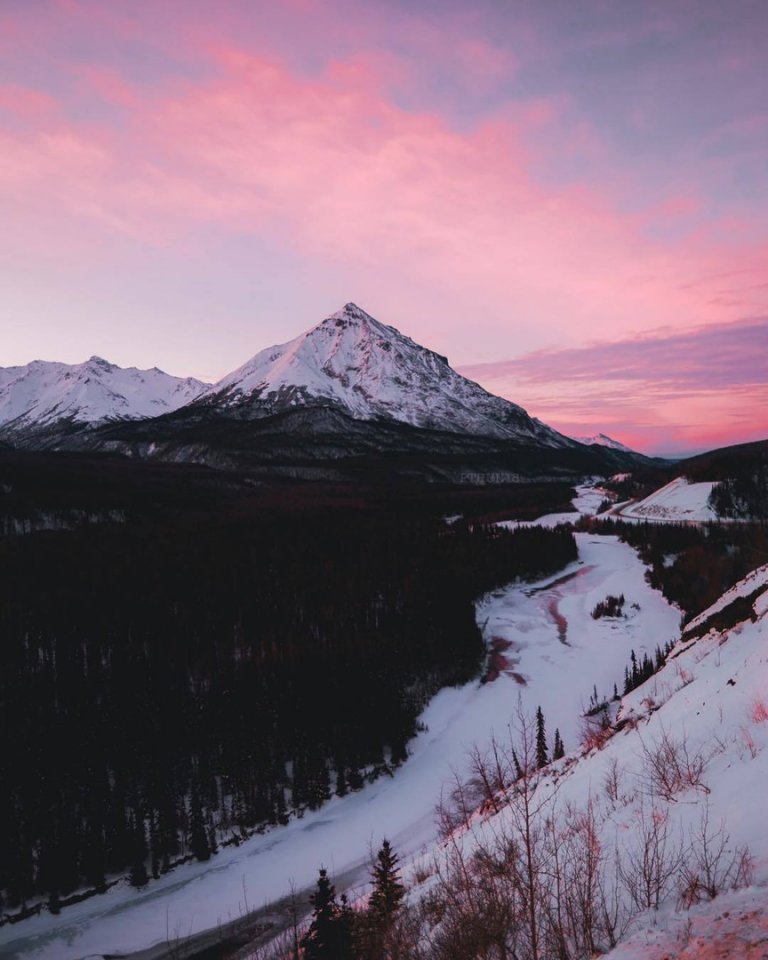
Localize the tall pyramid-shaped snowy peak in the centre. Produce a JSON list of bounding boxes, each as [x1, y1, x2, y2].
[[193, 303, 574, 447]]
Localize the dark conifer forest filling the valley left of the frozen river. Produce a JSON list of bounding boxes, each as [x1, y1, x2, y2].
[[0, 470, 576, 914]]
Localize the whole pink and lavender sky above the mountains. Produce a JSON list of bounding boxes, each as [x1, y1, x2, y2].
[[0, 0, 768, 451]]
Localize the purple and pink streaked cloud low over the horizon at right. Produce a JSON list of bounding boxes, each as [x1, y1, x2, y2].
[[461, 316, 768, 452]]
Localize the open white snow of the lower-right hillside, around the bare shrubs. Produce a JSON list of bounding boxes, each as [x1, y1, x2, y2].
[[404, 565, 768, 960]]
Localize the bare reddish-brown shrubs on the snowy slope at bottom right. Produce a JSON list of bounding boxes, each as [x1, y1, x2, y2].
[[265, 713, 752, 960]]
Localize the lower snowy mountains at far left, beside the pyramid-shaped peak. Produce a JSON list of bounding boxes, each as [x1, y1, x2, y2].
[[0, 357, 207, 436]]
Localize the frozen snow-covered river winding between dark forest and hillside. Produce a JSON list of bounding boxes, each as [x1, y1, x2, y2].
[[0, 489, 679, 960]]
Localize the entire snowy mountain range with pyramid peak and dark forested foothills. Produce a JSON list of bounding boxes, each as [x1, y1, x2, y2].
[[0, 303, 644, 482]]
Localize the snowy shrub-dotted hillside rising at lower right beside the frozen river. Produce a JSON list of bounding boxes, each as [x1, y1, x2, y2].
[[402, 565, 768, 960]]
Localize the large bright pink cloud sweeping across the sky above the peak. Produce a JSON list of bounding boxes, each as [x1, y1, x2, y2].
[[0, 22, 768, 406]]
